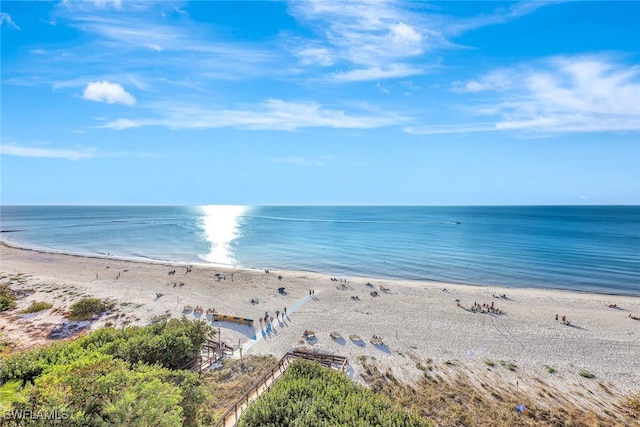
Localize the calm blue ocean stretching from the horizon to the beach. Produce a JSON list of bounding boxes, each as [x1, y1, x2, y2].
[[0, 205, 640, 296]]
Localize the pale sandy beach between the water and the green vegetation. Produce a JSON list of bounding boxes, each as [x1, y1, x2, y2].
[[0, 244, 640, 420]]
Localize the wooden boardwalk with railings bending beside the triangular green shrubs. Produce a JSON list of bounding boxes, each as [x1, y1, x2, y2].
[[214, 351, 347, 427]]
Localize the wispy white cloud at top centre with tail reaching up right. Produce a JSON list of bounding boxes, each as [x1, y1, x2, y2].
[[289, 0, 548, 81]]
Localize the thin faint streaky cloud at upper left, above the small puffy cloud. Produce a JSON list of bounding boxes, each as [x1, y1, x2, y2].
[[53, 7, 277, 78]]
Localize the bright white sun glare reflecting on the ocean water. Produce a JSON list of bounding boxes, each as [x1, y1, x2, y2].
[[200, 205, 249, 265]]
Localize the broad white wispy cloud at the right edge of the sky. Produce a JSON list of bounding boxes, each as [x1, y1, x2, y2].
[[405, 55, 640, 134]]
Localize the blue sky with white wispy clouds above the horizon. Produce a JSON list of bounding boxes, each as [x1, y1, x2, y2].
[[0, 0, 640, 205]]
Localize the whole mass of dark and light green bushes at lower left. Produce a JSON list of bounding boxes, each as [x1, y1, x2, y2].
[[0, 319, 213, 426]]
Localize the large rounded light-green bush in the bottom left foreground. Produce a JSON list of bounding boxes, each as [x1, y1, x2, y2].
[[16, 352, 183, 426]]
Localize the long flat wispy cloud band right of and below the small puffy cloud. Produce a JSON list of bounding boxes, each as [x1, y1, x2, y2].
[[100, 99, 408, 131]]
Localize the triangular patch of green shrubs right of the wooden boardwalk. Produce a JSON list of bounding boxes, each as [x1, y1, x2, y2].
[[239, 360, 429, 427]]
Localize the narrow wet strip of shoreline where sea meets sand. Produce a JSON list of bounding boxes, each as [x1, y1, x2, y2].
[[0, 239, 640, 297]]
